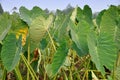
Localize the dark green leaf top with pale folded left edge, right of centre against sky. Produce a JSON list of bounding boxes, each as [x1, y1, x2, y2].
[[70, 5, 93, 26]]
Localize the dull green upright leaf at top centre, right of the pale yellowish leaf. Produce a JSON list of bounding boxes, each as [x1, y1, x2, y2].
[[51, 10, 71, 42]]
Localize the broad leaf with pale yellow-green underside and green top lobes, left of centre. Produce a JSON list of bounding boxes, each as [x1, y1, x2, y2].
[[20, 7, 53, 43]]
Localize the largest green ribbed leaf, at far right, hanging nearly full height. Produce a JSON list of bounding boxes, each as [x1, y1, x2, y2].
[[88, 6, 117, 74]]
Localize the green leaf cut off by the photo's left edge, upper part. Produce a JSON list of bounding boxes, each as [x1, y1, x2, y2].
[[0, 13, 11, 41]]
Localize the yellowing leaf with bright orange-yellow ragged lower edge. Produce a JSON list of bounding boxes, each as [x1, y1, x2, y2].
[[10, 13, 28, 46]]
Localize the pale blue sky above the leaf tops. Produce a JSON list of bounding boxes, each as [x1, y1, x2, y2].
[[0, 0, 120, 12]]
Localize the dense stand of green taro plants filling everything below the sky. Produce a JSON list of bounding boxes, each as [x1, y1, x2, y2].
[[0, 5, 120, 80]]
